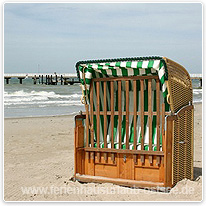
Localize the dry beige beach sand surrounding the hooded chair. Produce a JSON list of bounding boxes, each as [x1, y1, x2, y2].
[[4, 104, 202, 201]]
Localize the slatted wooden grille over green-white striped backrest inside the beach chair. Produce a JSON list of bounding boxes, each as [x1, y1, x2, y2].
[[85, 75, 169, 151]]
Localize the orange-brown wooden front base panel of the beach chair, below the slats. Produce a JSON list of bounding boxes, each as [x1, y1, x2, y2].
[[75, 148, 167, 187]]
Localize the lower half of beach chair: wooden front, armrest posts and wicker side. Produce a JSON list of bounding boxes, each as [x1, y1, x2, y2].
[[74, 105, 193, 188]]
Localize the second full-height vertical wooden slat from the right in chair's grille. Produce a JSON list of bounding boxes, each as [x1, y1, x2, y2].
[[148, 79, 152, 151]]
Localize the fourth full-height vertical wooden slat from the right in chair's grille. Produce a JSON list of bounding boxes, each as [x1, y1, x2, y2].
[[133, 80, 137, 150]]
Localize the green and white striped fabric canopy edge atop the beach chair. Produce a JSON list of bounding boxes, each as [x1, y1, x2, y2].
[[76, 57, 168, 103]]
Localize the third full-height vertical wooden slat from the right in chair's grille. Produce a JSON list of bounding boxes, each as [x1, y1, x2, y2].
[[140, 79, 144, 150]]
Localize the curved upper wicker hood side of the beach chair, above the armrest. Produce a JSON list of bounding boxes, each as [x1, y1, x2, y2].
[[164, 57, 193, 113]]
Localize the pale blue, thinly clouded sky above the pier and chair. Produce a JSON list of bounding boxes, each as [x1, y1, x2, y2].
[[4, 3, 202, 73]]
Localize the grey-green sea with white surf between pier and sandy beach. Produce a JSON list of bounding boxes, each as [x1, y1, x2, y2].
[[4, 78, 202, 118]]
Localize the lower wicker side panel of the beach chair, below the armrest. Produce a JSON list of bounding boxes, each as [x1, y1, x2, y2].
[[173, 110, 194, 185]]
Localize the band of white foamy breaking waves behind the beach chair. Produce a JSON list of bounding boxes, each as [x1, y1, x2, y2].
[[4, 89, 202, 108]]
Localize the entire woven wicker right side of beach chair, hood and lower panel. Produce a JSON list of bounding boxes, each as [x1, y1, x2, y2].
[[164, 58, 194, 186]]
